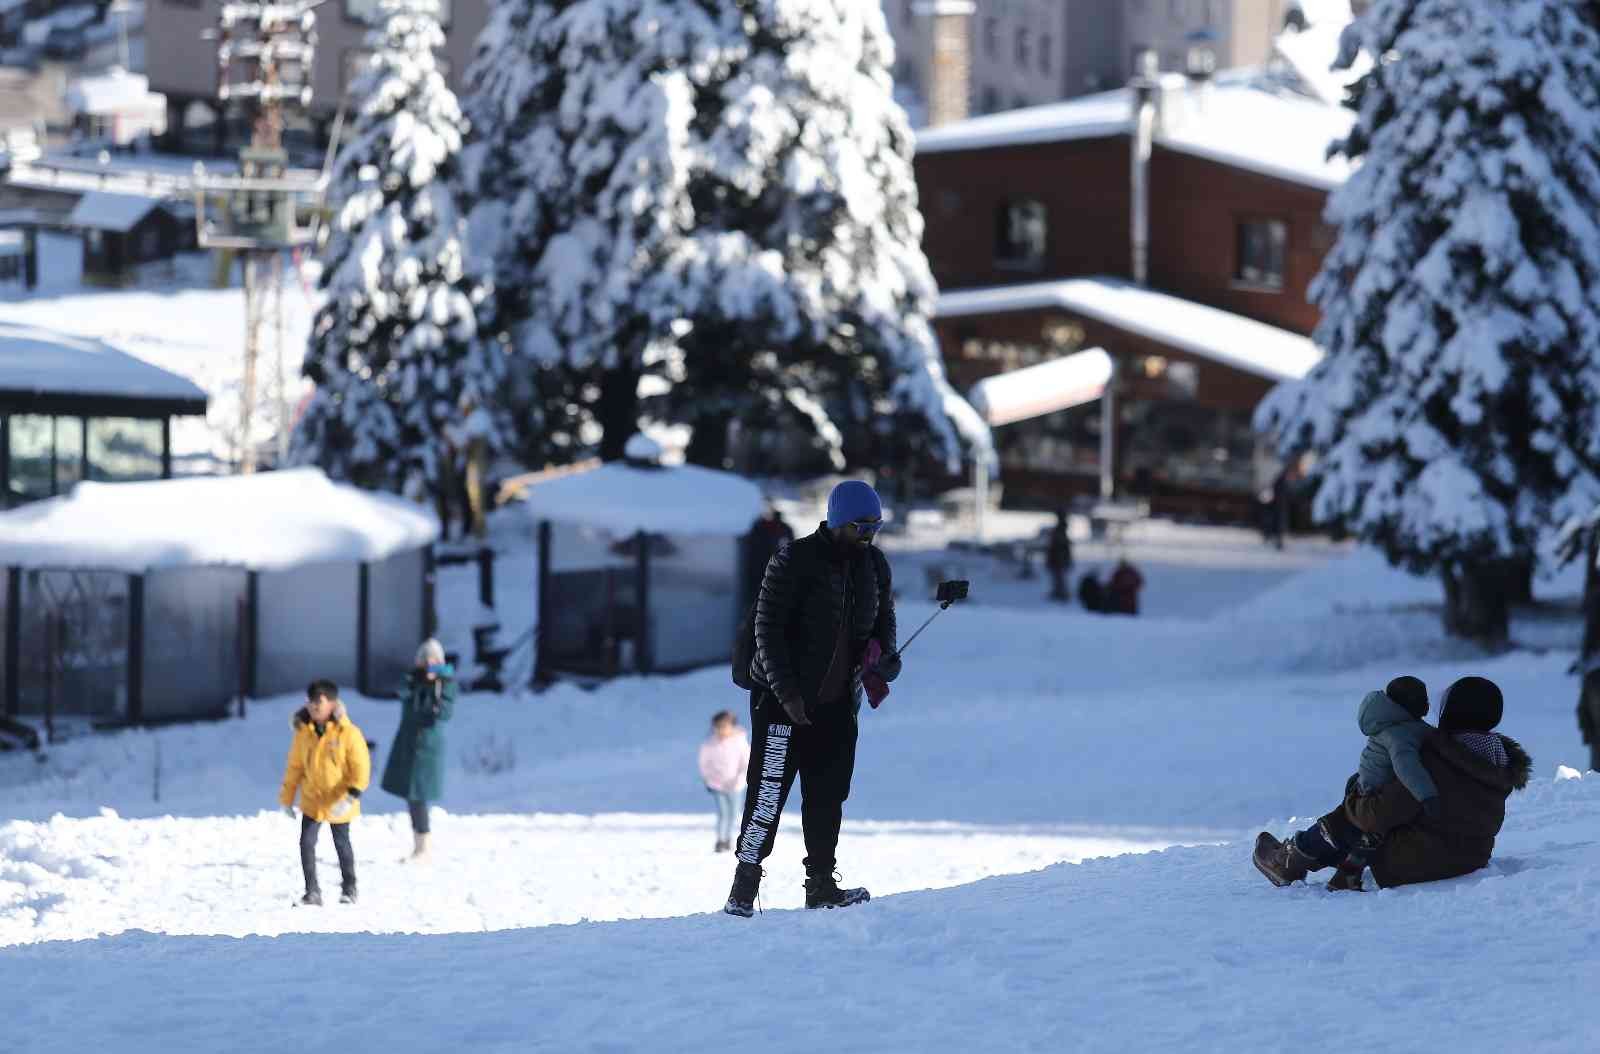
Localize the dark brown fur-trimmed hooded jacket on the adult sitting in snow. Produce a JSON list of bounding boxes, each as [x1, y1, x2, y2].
[[1344, 729, 1533, 886]]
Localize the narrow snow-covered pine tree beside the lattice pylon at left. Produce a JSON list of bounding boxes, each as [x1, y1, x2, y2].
[[294, 0, 504, 499]]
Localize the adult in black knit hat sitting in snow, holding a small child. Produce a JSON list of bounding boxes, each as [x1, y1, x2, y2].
[[1256, 677, 1533, 889]]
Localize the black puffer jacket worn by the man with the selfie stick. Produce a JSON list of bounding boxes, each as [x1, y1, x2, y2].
[[750, 525, 898, 710]]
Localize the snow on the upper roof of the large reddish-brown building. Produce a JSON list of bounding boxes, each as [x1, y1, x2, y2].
[[917, 69, 1354, 190]]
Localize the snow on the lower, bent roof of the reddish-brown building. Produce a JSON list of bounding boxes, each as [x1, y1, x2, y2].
[[934, 278, 1322, 381]]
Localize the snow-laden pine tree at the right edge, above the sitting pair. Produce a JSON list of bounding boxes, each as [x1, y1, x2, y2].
[[1258, 0, 1600, 638]]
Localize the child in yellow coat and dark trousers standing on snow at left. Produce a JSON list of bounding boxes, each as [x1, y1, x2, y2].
[[278, 681, 373, 905]]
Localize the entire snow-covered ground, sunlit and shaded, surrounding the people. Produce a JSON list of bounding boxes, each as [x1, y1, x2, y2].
[[0, 526, 1600, 1052]]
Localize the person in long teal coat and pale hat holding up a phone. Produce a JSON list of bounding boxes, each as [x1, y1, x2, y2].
[[382, 637, 456, 860]]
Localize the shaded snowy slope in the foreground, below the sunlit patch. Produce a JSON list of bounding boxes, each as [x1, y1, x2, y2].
[[0, 776, 1600, 1054]]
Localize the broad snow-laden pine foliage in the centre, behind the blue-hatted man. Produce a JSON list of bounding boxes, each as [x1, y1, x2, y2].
[[467, 0, 989, 462]]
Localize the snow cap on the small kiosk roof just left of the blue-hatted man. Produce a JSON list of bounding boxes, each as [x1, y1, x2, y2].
[[523, 461, 762, 534]]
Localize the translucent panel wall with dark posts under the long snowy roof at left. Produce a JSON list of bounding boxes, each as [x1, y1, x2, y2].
[[0, 549, 434, 737]]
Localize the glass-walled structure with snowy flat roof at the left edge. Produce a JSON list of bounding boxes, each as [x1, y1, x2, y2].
[[0, 325, 206, 509]]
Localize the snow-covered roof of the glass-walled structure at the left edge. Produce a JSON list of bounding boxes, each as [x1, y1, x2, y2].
[[0, 321, 206, 413]]
